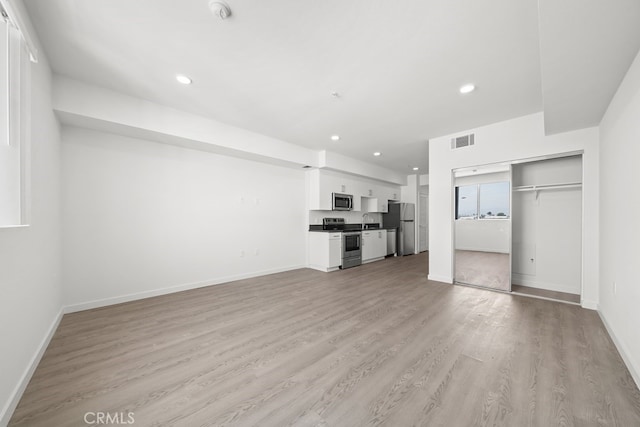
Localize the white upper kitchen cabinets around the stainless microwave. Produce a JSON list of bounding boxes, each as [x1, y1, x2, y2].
[[307, 169, 400, 212]]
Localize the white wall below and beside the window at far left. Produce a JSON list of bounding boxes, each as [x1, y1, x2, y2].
[[0, 14, 62, 425]]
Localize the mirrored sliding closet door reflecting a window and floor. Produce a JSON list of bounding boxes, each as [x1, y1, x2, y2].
[[453, 165, 511, 292]]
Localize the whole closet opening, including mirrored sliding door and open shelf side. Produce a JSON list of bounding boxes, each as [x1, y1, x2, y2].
[[452, 154, 582, 304]]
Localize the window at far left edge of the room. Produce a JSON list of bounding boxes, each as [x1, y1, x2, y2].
[[0, 0, 35, 227]]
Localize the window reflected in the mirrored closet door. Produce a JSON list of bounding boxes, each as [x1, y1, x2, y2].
[[456, 182, 511, 220]]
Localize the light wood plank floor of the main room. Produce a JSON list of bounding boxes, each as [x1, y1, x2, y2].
[[10, 254, 640, 426]]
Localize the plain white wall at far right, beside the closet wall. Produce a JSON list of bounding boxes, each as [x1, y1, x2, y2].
[[599, 47, 640, 385]]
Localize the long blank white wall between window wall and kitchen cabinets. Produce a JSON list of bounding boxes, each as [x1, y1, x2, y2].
[[62, 127, 308, 310]]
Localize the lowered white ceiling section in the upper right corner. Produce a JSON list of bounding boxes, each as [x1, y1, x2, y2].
[[539, 0, 640, 134]]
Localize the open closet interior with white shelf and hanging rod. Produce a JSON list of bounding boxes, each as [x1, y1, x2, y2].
[[511, 155, 582, 303]]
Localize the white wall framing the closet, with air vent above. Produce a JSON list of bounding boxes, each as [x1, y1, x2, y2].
[[429, 113, 599, 308]]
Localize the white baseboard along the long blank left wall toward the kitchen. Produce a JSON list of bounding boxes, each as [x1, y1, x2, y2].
[[64, 265, 305, 313]]
